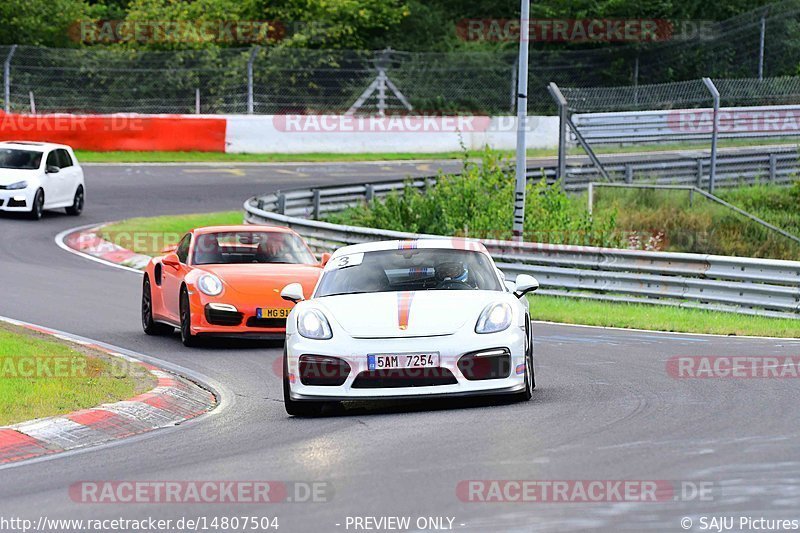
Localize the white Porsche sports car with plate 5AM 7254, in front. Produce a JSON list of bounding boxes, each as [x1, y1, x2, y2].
[[281, 239, 539, 416]]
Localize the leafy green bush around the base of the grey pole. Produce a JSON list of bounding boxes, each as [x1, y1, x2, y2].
[[327, 150, 625, 246]]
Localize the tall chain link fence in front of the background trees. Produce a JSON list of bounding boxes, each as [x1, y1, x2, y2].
[[0, 0, 800, 114]]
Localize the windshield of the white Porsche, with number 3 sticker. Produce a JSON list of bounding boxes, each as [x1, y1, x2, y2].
[[314, 248, 503, 297]]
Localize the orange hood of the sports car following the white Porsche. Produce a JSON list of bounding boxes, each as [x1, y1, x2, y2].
[[197, 263, 322, 296]]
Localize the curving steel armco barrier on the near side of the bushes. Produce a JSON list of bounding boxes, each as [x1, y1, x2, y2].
[[244, 178, 800, 319]]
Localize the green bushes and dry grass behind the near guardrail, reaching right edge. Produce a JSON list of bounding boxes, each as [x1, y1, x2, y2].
[[327, 151, 800, 260]]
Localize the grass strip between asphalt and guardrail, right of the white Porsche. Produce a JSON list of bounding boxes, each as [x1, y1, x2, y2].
[[529, 295, 800, 338]]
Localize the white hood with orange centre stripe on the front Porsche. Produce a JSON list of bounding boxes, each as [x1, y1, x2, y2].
[[312, 290, 503, 339]]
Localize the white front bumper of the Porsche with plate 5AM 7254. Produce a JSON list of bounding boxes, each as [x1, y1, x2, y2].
[[286, 327, 526, 401]]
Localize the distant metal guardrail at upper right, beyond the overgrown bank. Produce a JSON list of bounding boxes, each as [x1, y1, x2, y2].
[[572, 105, 800, 144]]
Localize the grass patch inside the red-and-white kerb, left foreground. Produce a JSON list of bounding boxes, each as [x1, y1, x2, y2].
[[0, 324, 156, 425]]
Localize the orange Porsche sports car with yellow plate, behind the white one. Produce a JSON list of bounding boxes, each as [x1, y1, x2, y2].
[[142, 226, 330, 346]]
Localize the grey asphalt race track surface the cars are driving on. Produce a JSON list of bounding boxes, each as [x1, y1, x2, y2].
[[0, 159, 800, 532]]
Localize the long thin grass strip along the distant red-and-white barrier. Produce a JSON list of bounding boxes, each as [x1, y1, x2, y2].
[[76, 138, 797, 163]]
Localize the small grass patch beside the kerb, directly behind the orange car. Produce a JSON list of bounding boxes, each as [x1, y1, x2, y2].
[[101, 211, 244, 256]]
